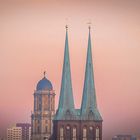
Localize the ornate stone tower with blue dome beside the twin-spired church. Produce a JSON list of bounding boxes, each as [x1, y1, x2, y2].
[[31, 72, 55, 140]]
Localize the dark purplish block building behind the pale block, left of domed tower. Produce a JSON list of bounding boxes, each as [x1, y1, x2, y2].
[[16, 123, 31, 140]]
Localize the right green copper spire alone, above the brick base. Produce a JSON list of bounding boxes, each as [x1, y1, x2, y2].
[[81, 26, 102, 120]]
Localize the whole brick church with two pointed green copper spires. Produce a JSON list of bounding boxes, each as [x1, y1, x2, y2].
[[52, 26, 102, 140]]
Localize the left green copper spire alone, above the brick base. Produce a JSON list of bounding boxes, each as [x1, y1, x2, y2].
[[55, 26, 75, 120]]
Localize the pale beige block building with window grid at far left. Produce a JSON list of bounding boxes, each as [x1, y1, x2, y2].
[[7, 126, 22, 140]]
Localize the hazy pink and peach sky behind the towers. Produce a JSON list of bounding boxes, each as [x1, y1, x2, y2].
[[0, 0, 140, 140]]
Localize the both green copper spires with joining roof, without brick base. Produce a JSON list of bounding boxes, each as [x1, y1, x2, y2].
[[55, 26, 102, 120]]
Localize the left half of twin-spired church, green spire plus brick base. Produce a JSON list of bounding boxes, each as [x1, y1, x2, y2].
[[53, 26, 78, 140]]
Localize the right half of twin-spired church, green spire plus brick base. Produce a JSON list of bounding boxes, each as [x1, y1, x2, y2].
[[79, 26, 102, 140]]
